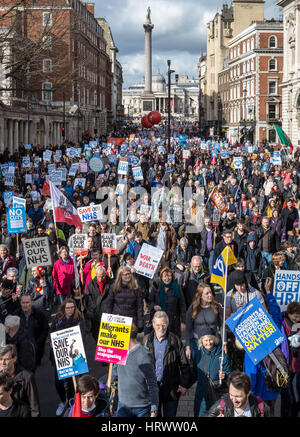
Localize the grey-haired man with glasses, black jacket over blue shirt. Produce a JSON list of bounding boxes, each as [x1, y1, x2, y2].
[[145, 311, 192, 417]]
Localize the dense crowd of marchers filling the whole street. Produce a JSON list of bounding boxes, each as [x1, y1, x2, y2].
[[0, 126, 300, 418]]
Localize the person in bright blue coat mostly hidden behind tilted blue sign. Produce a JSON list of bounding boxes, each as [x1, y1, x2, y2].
[[244, 278, 282, 415]]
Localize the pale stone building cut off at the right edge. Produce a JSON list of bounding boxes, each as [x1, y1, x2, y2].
[[277, 0, 300, 150]]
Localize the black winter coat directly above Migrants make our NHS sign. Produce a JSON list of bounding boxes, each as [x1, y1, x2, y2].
[[104, 285, 144, 330]]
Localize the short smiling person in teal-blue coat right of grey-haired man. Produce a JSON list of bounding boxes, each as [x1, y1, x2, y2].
[[192, 327, 231, 417]]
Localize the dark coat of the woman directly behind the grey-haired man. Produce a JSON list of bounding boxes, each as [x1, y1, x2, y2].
[[149, 281, 186, 337]]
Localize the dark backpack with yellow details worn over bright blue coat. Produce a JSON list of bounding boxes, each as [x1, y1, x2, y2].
[[263, 347, 291, 392]]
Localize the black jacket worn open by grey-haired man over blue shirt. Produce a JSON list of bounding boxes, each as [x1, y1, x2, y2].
[[145, 331, 192, 402]]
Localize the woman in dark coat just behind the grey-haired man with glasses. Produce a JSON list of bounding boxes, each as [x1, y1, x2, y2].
[[149, 267, 186, 337]]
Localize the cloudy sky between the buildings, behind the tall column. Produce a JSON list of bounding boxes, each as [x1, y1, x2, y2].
[[94, 0, 281, 88]]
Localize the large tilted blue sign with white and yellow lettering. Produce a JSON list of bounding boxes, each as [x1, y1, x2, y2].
[[226, 297, 284, 365]]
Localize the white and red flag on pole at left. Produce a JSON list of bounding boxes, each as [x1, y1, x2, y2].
[[49, 181, 82, 228]]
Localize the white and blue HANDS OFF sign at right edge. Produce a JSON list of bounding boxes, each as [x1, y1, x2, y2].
[[273, 270, 300, 311]]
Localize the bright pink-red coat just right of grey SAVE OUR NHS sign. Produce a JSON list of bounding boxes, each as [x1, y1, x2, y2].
[[52, 258, 75, 296]]
